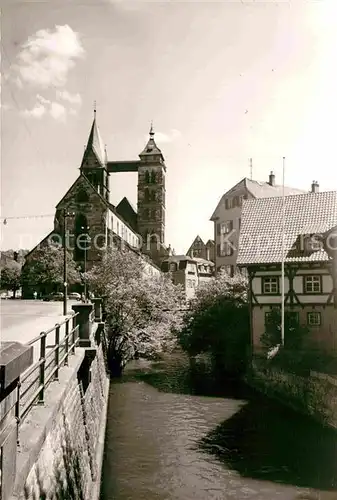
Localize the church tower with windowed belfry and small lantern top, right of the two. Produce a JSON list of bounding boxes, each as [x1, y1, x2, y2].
[[137, 124, 166, 257]]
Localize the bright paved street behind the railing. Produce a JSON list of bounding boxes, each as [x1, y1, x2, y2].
[[0, 299, 76, 343]]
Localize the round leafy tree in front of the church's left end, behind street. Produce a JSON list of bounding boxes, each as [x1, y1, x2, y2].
[[22, 245, 80, 293]]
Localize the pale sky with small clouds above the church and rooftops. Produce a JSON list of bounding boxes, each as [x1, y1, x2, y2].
[[0, 0, 337, 253]]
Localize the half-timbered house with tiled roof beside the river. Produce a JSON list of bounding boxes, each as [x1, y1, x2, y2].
[[238, 192, 337, 350]]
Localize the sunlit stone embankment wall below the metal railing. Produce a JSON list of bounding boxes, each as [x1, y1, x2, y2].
[[13, 345, 109, 500]]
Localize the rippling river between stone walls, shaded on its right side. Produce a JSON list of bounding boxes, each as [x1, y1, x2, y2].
[[101, 361, 337, 500]]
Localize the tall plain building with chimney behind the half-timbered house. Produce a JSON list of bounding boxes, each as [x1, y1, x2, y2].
[[210, 172, 304, 276]]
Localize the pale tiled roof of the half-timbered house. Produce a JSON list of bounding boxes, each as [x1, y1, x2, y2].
[[237, 191, 337, 265]]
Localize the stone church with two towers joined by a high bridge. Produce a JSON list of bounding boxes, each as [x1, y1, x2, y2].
[[23, 110, 170, 297]]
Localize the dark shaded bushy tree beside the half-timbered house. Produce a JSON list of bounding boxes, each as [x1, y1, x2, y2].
[[179, 272, 249, 374]]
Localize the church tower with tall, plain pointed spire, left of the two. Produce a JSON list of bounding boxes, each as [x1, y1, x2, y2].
[[80, 109, 109, 201]]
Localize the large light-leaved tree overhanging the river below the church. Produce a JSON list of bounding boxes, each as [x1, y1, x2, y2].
[[87, 249, 182, 375]]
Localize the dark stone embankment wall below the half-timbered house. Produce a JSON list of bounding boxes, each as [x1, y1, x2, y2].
[[246, 362, 337, 429]]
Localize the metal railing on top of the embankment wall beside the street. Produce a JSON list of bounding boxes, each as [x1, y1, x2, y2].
[[15, 313, 79, 423]]
